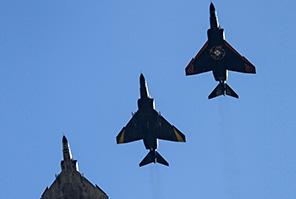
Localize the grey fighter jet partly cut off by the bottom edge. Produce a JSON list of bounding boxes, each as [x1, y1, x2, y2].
[[41, 136, 109, 199]]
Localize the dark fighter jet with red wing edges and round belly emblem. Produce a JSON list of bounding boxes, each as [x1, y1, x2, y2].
[[185, 3, 256, 99]]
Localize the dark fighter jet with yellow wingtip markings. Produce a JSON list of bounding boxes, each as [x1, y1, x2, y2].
[[116, 74, 185, 167]]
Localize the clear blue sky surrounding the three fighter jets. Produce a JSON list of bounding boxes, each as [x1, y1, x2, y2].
[[0, 0, 296, 199]]
